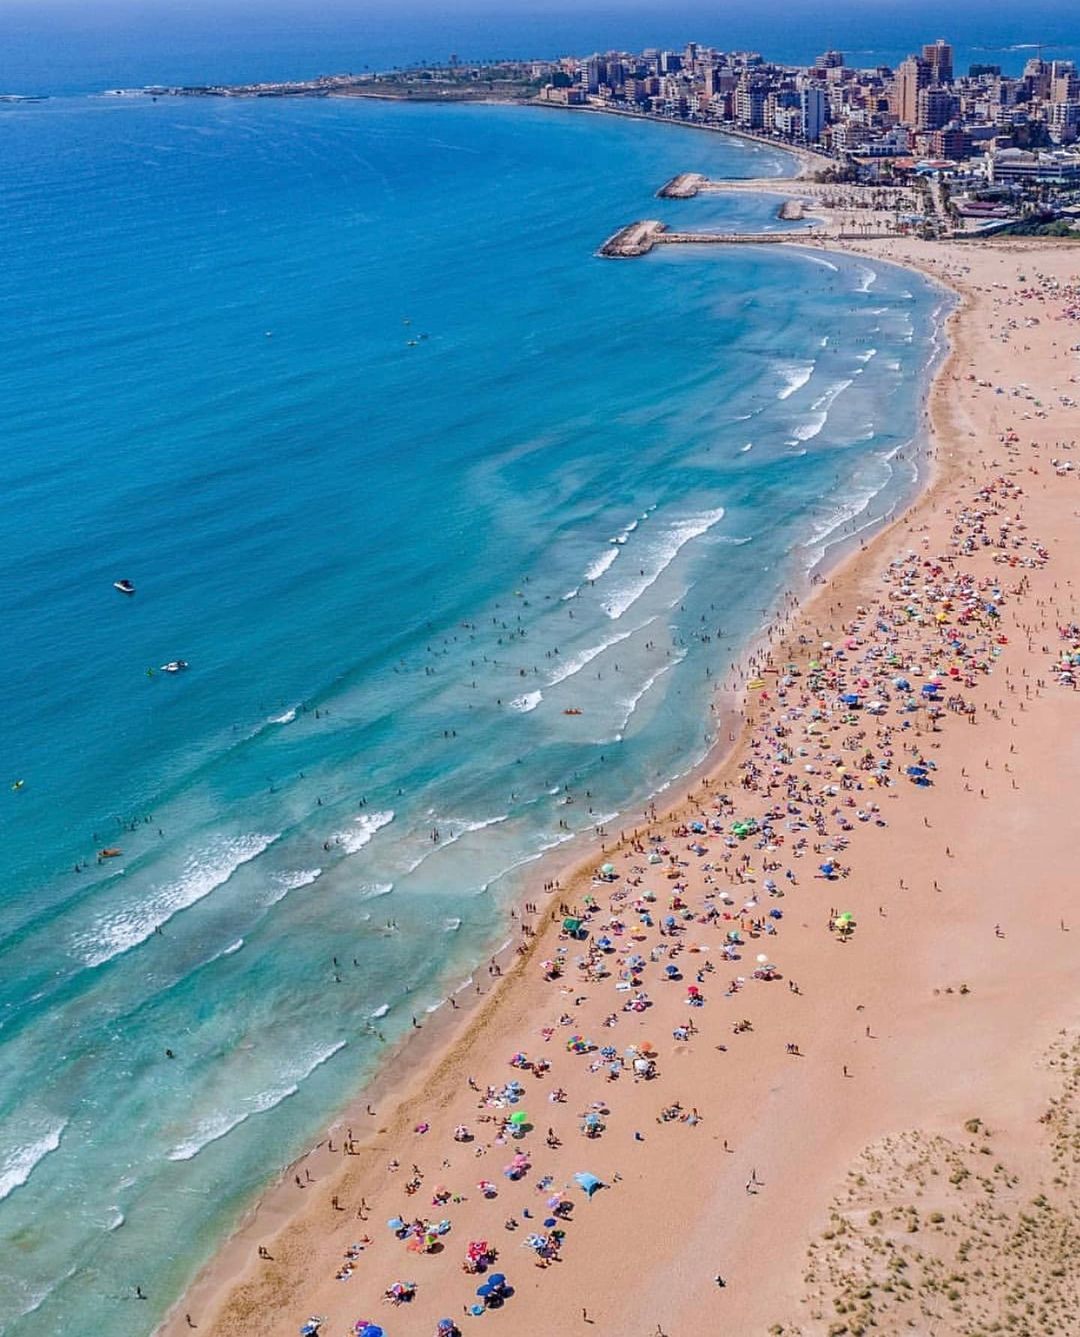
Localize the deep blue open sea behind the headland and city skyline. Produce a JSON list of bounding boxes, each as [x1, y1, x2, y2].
[[0, 0, 1080, 94]]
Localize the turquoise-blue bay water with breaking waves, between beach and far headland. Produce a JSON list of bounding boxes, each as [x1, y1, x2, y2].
[[0, 99, 940, 1337]]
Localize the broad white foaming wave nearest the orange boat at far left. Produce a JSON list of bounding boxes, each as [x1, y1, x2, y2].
[[72, 832, 281, 968]]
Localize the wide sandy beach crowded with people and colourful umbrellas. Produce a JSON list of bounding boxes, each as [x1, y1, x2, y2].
[[162, 229, 1080, 1337]]
